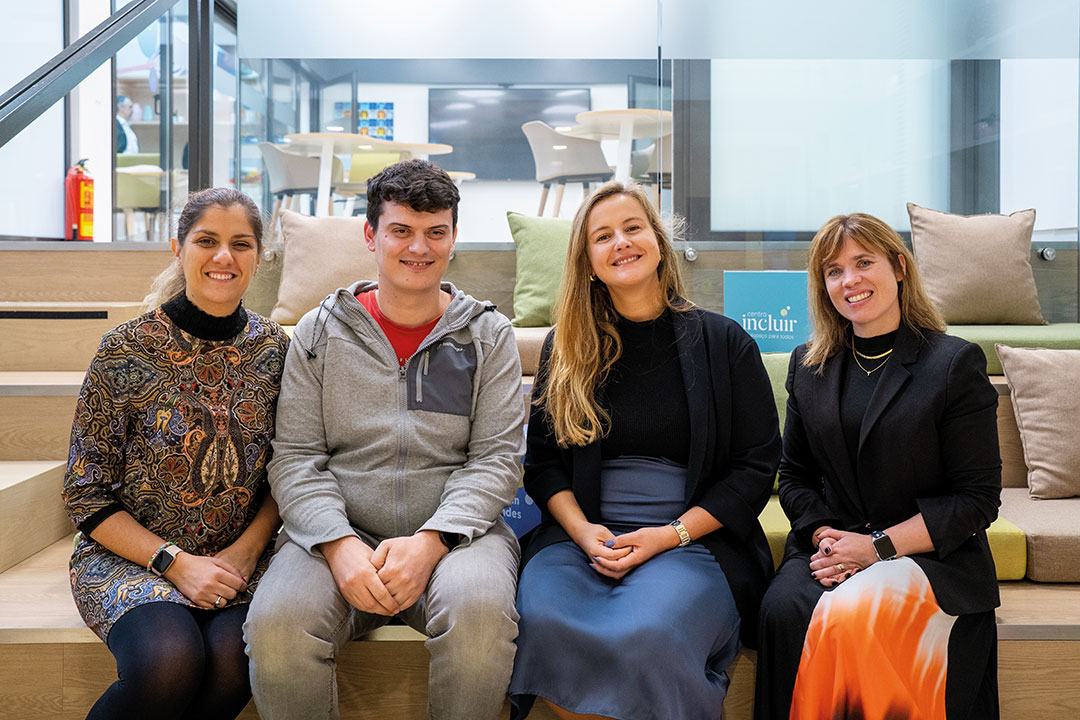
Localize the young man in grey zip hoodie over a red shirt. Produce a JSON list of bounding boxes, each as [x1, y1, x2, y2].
[[244, 160, 524, 720]]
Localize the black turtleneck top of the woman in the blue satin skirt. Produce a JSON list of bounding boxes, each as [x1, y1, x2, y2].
[[600, 310, 690, 465]]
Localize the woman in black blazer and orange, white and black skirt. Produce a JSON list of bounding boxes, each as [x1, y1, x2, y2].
[[755, 214, 1001, 720]]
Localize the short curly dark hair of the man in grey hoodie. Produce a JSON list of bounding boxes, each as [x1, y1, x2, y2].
[[367, 160, 461, 228]]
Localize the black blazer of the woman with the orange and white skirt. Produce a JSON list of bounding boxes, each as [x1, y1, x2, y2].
[[780, 325, 1001, 615]]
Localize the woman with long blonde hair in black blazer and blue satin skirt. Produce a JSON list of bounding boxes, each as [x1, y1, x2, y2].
[[510, 182, 780, 720]]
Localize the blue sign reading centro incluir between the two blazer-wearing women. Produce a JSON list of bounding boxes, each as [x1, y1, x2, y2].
[[724, 270, 810, 353]]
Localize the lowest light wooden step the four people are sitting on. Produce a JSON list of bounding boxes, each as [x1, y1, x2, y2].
[[0, 536, 1080, 720]]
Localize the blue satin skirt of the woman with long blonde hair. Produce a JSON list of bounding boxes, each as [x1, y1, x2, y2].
[[510, 458, 739, 720]]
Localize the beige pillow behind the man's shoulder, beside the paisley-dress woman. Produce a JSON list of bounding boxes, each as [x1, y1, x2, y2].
[[270, 210, 378, 325]]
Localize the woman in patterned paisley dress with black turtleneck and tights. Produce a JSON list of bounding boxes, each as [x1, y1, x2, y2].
[[64, 188, 288, 720]]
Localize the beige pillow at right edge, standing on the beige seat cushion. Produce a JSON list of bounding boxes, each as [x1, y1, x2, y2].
[[995, 344, 1080, 500]]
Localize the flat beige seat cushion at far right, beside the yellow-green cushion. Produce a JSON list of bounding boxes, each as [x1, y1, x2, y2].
[[1000, 488, 1080, 583]]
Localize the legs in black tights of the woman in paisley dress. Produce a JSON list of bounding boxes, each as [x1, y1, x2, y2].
[[86, 602, 252, 720]]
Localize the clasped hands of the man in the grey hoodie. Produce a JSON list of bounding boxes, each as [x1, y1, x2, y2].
[[320, 530, 448, 616]]
